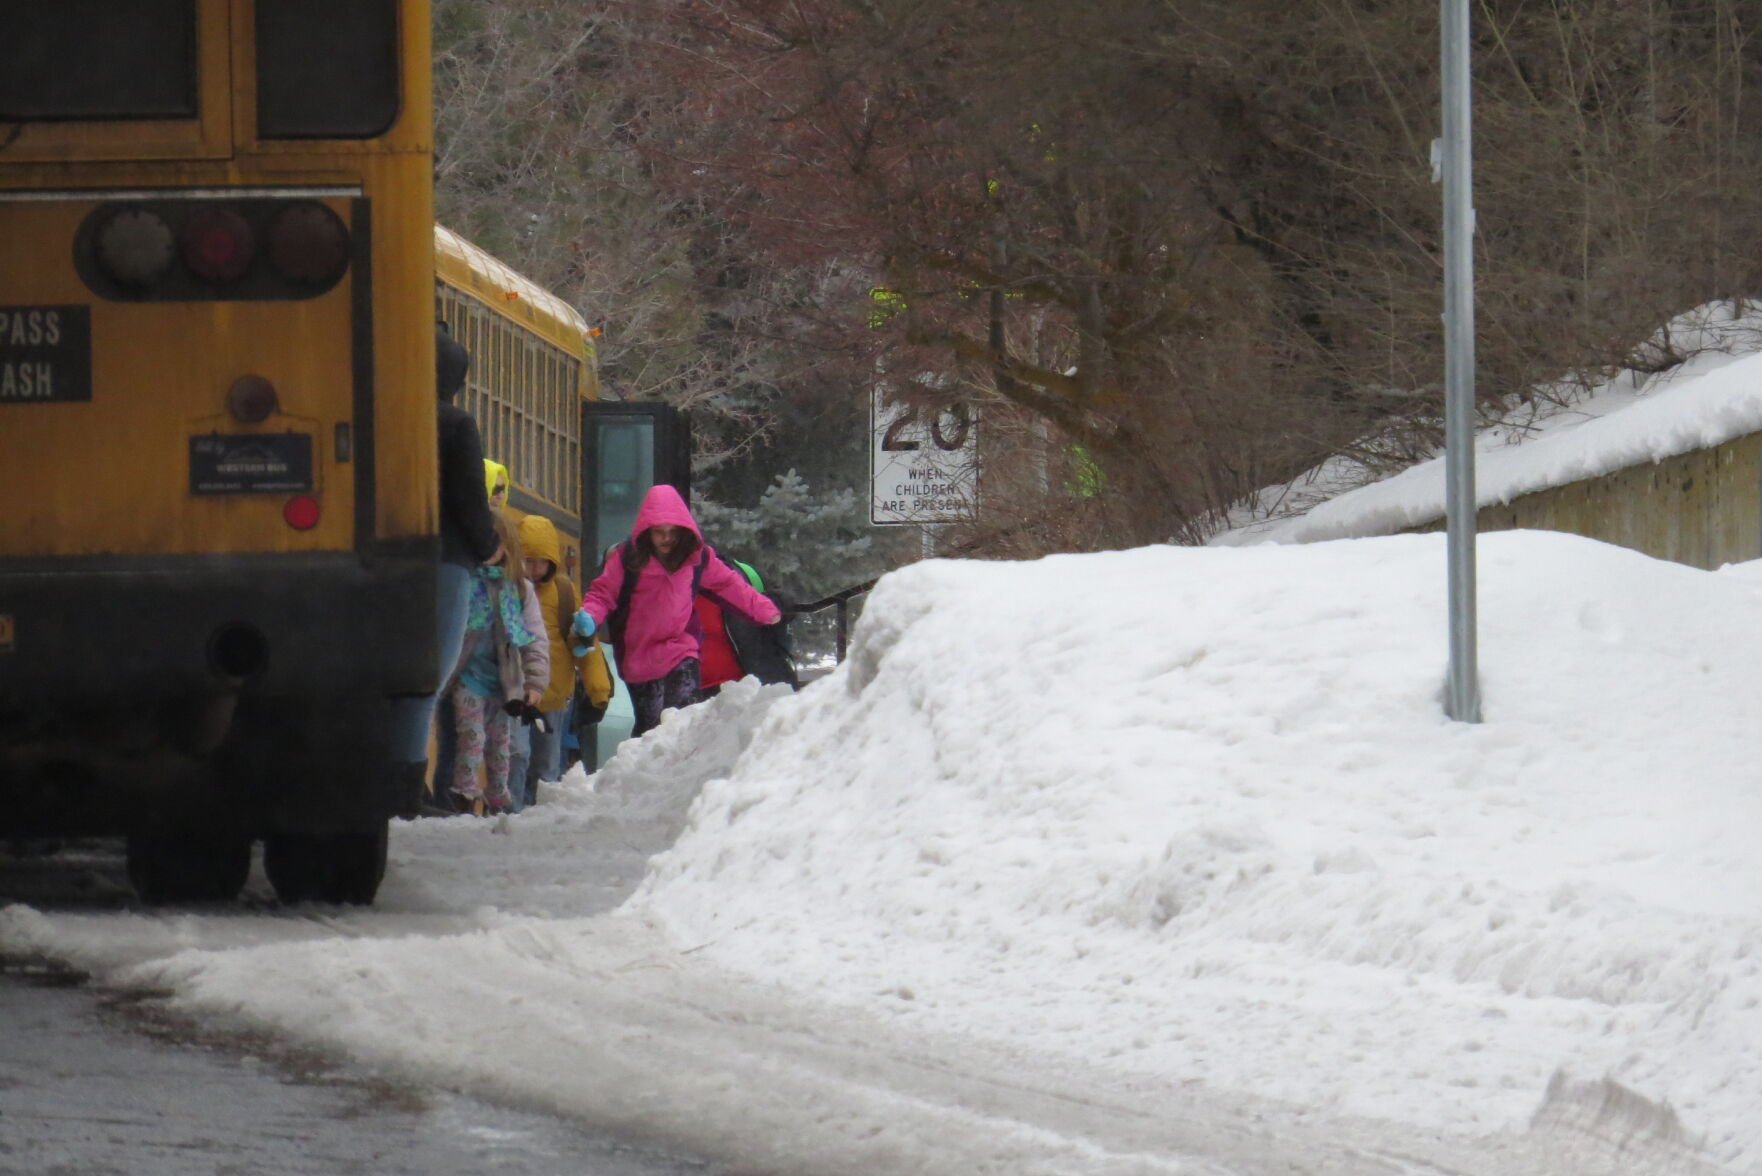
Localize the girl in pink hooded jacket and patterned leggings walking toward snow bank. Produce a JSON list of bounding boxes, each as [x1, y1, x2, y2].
[[574, 485, 782, 735]]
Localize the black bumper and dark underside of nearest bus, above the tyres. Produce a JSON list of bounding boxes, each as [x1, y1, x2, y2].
[[0, 550, 439, 836]]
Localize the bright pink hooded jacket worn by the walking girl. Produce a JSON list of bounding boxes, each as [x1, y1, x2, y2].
[[581, 485, 782, 682]]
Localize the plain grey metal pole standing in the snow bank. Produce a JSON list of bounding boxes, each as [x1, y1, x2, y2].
[[1441, 0, 1480, 723]]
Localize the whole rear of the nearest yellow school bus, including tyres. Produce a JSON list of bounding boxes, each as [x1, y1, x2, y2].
[[0, 0, 439, 901]]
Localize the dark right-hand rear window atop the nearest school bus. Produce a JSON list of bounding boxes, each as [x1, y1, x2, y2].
[[257, 0, 400, 139]]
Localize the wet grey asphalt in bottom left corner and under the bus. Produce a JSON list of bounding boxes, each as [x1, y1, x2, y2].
[[0, 855, 714, 1176]]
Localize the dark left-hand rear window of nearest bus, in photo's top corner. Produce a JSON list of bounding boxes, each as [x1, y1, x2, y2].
[[0, 0, 196, 122]]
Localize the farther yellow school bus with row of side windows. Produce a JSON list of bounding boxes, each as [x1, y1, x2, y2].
[[435, 224, 599, 582]]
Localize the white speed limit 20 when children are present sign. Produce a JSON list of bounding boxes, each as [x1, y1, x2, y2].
[[869, 388, 980, 525]]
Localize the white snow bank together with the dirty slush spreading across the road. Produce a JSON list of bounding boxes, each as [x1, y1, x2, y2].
[[0, 532, 1762, 1176]]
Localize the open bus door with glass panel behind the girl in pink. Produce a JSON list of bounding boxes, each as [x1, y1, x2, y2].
[[581, 400, 691, 571]]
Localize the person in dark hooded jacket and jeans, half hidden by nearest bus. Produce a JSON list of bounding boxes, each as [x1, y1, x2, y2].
[[385, 323, 502, 775]]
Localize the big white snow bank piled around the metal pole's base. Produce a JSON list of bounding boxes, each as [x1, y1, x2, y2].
[[626, 532, 1762, 1169]]
